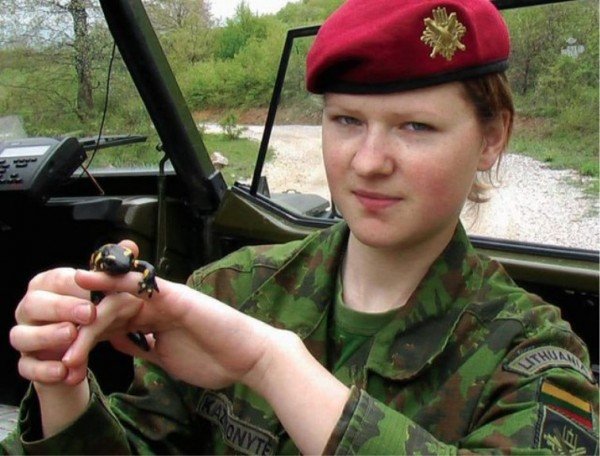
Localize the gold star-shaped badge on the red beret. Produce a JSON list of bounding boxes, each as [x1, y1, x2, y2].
[[421, 8, 467, 60]]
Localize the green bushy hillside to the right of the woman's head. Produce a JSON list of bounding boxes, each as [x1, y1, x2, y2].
[[506, 0, 600, 183]]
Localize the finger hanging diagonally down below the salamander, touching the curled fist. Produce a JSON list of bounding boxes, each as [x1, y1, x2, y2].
[[62, 293, 144, 367]]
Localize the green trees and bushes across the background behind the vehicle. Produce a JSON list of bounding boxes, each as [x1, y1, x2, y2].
[[0, 0, 599, 193]]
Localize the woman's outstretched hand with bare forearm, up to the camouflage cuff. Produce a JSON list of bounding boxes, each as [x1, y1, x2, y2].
[[70, 246, 349, 454]]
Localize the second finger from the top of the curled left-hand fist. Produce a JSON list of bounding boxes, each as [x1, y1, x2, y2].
[[15, 290, 96, 325]]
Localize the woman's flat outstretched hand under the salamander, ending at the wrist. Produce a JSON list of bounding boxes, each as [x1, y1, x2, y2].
[[63, 271, 281, 388]]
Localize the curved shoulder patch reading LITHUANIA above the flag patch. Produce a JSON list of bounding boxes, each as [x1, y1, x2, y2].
[[504, 345, 594, 382]]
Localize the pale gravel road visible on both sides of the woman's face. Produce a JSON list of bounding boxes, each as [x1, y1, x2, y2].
[[207, 125, 600, 250]]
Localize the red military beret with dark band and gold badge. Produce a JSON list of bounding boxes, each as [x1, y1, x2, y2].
[[306, 0, 510, 93]]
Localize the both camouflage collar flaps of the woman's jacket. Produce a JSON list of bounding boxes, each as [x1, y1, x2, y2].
[[241, 222, 483, 380]]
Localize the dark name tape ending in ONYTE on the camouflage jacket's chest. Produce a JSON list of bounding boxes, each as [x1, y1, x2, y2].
[[197, 391, 278, 455]]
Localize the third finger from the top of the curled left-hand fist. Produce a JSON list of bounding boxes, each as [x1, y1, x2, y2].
[[9, 323, 77, 353]]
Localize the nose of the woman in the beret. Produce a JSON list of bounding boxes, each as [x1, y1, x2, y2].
[[352, 128, 395, 177]]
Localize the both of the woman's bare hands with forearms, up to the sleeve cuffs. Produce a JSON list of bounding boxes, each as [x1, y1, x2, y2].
[[11, 239, 348, 453]]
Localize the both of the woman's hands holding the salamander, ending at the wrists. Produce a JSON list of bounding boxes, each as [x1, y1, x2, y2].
[[11, 235, 278, 388]]
